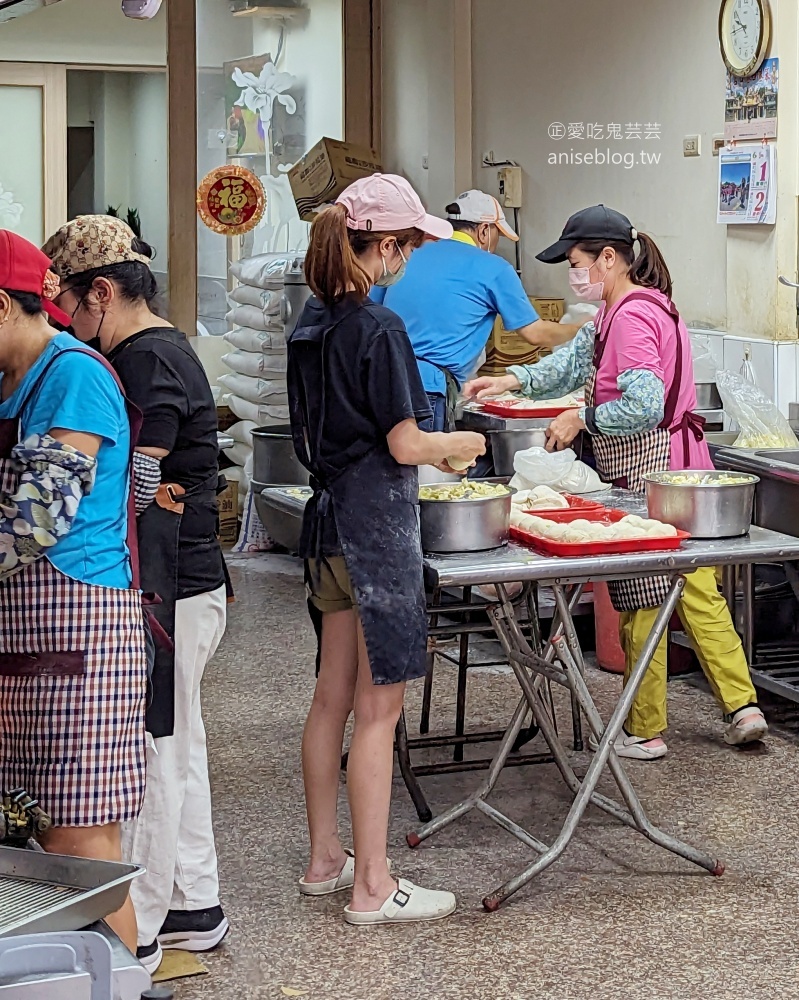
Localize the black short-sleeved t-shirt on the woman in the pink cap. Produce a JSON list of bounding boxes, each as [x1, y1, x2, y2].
[[288, 295, 431, 555]]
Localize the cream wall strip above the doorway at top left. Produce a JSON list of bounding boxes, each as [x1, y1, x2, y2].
[[0, 0, 166, 66]]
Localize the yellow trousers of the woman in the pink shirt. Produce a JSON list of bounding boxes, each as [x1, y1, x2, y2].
[[619, 568, 757, 739]]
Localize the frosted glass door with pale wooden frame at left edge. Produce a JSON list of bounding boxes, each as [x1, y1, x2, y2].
[[0, 63, 67, 246]]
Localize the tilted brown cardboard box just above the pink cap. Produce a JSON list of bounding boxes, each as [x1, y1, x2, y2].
[[289, 139, 383, 222]]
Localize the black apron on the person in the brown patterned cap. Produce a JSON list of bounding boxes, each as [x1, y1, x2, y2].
[[112, 327, 228, 739]]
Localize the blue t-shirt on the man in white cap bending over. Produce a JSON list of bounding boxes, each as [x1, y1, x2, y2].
[[372, 239, 538, 393]]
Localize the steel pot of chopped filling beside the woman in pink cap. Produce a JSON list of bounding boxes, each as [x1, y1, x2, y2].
[[419, 483, 516, 553]]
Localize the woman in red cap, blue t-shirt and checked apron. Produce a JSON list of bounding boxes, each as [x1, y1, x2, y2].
[[0, 230, 147, 948]]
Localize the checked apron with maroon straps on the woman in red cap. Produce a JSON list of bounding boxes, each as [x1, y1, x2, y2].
[[0, 348, 147, 826]]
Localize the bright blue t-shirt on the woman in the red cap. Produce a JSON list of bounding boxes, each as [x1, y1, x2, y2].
[[0, 333, 131, 590]]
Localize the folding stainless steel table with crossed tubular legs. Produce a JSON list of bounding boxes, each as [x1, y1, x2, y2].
[[416, 490, 799, 911]]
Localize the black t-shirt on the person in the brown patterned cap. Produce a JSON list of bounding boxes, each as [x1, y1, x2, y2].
[[108, 327, 225, 599]]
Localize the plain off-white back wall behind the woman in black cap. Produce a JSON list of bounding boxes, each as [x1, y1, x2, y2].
[[473, 0, 727, 326]]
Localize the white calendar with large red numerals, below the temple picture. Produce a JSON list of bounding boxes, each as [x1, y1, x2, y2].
[[718, 143, 777, 225]]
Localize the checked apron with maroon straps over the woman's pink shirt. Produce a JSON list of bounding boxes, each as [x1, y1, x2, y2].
[[585, 292, 705, 611]]
